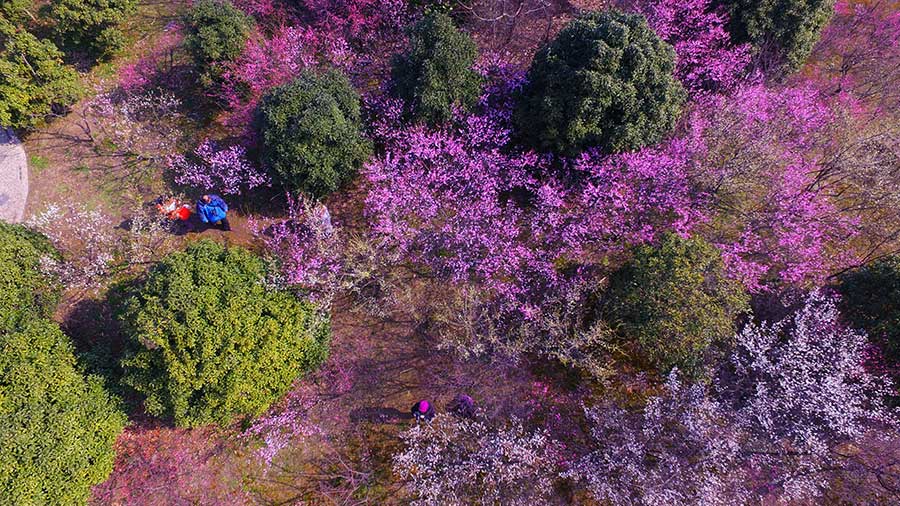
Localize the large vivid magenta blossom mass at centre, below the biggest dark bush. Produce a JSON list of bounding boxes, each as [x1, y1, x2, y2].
[[364, 69, 702, 360]]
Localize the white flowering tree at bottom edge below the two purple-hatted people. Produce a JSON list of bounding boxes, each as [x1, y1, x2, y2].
[[394, 414, 559, 505]]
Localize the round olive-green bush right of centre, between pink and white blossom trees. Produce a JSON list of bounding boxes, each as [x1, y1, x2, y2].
[[604, 234, 749, 376]]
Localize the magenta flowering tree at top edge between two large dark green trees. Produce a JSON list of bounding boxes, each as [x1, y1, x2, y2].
[[626, 0, 751, 96]]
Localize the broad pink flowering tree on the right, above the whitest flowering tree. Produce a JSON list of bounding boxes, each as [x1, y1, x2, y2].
[[687, 85, 860, 291]]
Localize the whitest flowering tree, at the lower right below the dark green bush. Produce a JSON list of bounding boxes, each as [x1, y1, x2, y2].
[[716, 291, 897, 500]]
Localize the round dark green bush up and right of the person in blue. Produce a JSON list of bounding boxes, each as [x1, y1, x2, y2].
[[257, 70, 372, 199]]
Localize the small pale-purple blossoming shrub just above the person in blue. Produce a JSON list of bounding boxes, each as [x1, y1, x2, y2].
[[168, 139, 270, 195]]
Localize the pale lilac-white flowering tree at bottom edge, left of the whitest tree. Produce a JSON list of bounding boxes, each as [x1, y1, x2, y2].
[[563, 370, 749, 505]]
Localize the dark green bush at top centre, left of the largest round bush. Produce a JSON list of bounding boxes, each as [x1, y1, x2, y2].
[[392, 13, 481, 125]]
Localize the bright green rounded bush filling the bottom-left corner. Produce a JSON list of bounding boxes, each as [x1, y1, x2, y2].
[[0, 320, 126, 505]]
